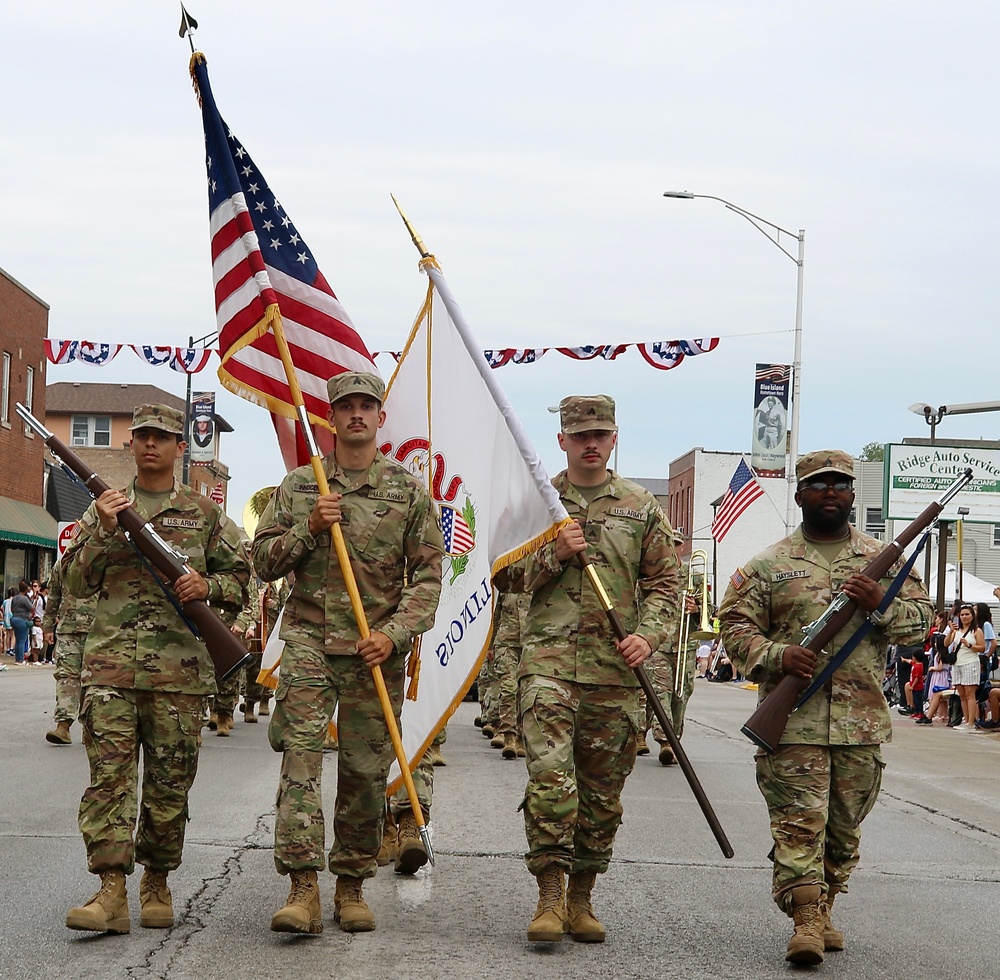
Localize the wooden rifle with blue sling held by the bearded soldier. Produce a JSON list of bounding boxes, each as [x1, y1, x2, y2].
[[740, 469, 972, 752]]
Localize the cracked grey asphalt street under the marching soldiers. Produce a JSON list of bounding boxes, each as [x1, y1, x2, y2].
[[0, 658, 1000, 980]]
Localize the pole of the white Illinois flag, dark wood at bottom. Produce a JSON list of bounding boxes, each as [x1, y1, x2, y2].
[[392, 197, 733, 858]]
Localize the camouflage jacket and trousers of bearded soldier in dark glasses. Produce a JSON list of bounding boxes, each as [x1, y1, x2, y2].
[[719, 526, 933, 915]]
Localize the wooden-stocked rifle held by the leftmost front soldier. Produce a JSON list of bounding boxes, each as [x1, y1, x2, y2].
[[15, 402, 253, 681]]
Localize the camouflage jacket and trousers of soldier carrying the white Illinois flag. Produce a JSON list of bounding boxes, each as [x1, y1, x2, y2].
[[495, 471, 678, 876]]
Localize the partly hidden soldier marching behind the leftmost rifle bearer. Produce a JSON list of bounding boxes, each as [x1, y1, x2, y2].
[[42, 561, 97, 745]]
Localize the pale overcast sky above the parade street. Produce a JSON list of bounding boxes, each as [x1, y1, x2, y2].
[[0, 0, 1000, 517]]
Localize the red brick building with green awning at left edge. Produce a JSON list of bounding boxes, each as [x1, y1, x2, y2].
[[0, 269, 56, 595]]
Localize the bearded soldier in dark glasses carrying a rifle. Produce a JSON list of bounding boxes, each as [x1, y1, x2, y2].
[[719, 450, 933, 964]]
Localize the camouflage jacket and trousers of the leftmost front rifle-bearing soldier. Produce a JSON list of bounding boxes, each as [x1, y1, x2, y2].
[[62, 472, 250, 874]]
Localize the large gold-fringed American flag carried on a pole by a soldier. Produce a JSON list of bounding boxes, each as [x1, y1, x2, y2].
[[191, 55, 375, 462]]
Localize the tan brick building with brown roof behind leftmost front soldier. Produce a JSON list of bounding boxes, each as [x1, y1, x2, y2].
[[45, 381, 233, 506]]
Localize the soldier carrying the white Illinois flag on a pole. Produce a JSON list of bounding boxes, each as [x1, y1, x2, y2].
[[495, 395, 678, 942]]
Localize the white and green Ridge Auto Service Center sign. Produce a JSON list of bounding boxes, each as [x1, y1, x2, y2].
[[882, 443, 1000, 524]]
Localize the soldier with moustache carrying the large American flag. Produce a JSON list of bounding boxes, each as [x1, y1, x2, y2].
[[252, 372, 444, 933]]
